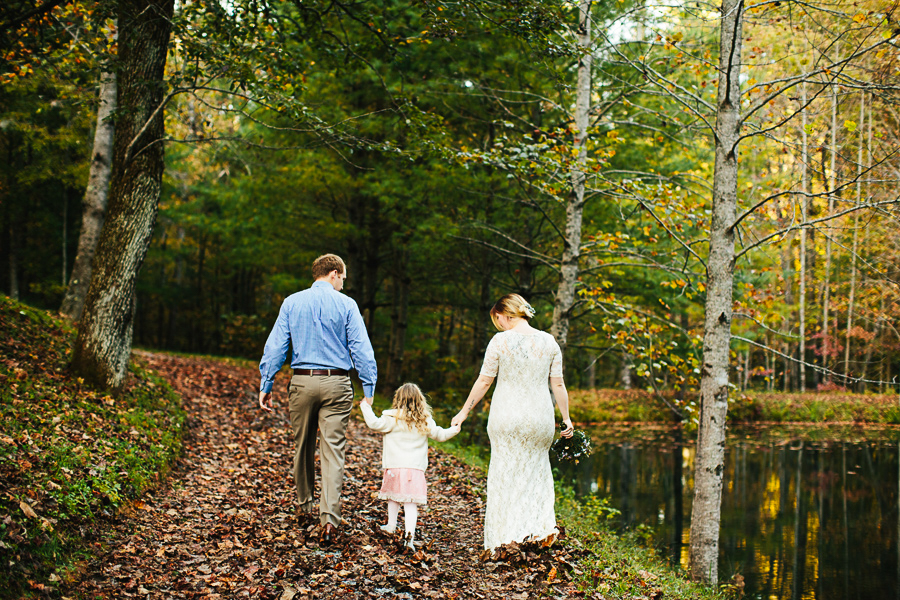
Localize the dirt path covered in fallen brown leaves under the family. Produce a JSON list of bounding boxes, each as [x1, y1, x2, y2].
[[74, 354, 577, 600]]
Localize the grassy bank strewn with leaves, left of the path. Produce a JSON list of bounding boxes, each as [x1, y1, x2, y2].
[[0, 297, 185, 598]]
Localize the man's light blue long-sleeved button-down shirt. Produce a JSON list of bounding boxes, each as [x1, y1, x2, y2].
[[259, 281, 378, 398]]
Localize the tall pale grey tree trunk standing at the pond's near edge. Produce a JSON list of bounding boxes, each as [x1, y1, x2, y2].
[[690, 0, 744, 584]]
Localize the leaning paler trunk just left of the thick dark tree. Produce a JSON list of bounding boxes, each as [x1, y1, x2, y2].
[[59, 67, 116, 321]]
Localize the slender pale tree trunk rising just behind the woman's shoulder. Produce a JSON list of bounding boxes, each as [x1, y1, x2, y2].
[[550, 0, 592, 353]]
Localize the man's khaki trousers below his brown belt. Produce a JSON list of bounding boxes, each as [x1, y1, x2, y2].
[[288, 375, 353, 526]]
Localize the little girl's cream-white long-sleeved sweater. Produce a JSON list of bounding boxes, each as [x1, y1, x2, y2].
[[360, 402, 459, 471]]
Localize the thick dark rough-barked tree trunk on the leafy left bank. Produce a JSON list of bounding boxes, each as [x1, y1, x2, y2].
[[72, 0, 174, 393]]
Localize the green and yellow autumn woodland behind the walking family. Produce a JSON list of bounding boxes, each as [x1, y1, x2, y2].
[[0, 0, 900, 412]]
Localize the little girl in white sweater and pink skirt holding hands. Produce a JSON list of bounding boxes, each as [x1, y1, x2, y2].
[[359, 383, 460, 550]]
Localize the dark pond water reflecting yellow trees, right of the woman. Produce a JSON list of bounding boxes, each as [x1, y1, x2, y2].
[[556, 426, 900, 600]]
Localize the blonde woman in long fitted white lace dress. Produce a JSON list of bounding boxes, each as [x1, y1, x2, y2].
[[450, 294, 574, 549]]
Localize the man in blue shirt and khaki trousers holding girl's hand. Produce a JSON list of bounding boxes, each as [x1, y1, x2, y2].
[[259, 254, 378, 544]]
